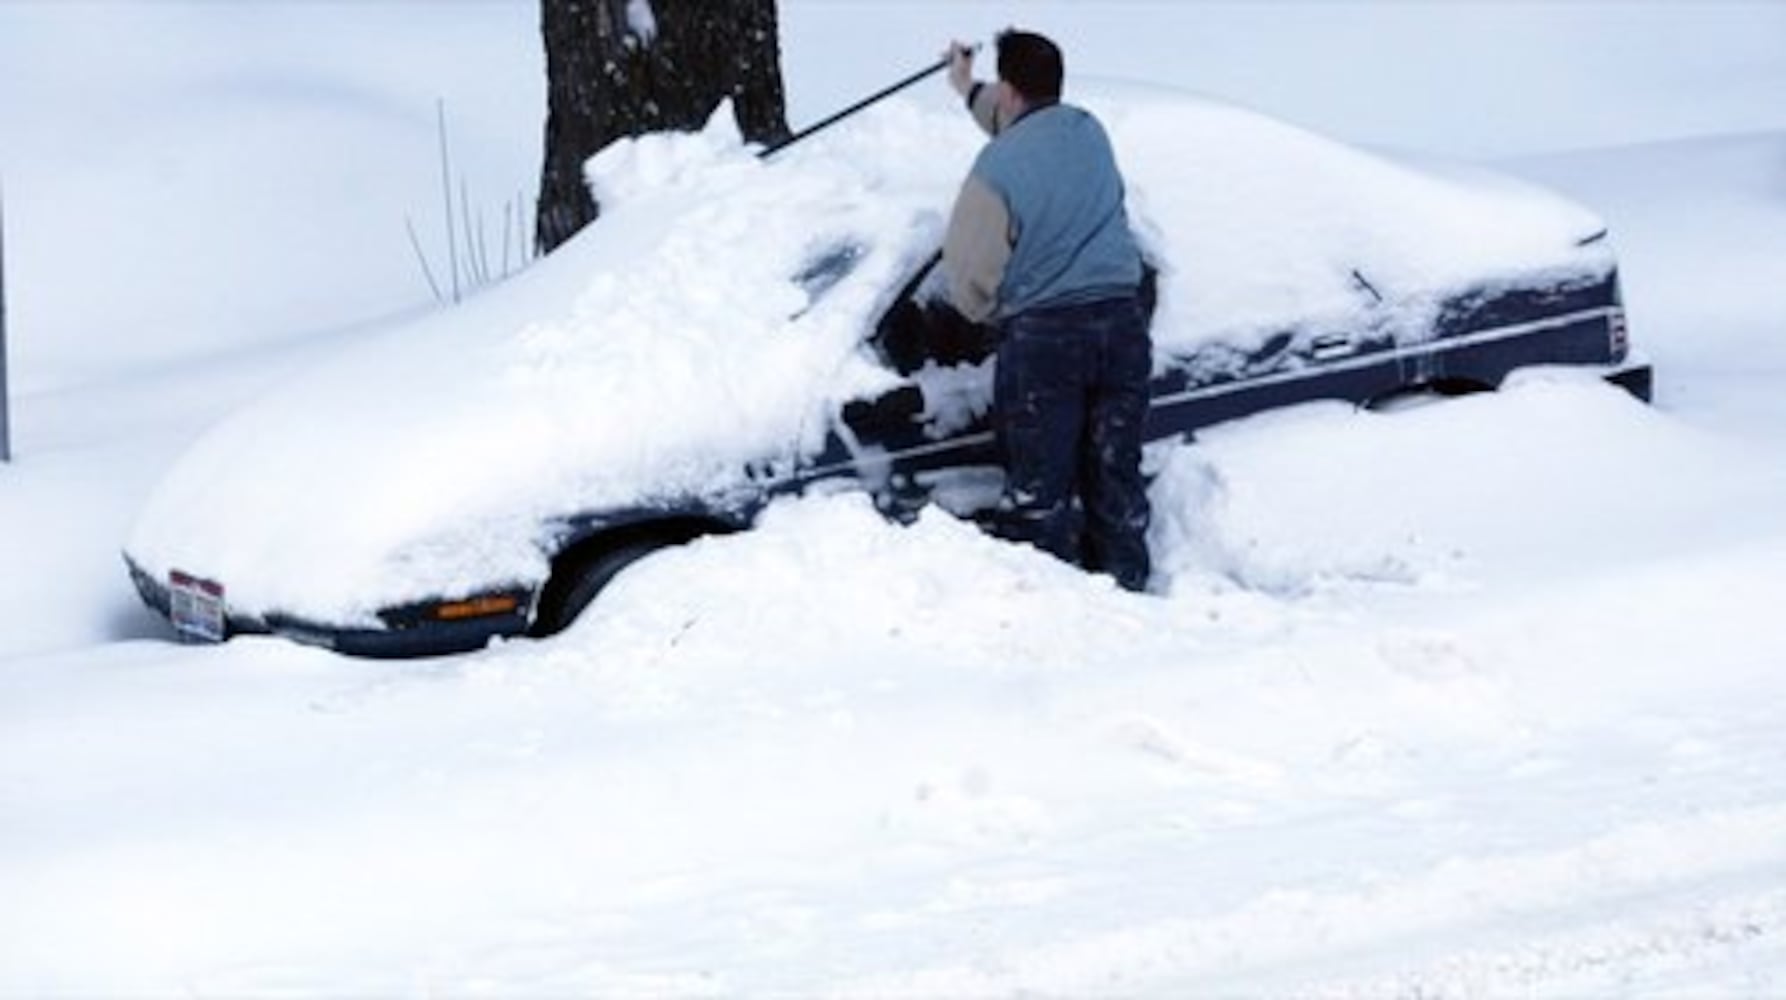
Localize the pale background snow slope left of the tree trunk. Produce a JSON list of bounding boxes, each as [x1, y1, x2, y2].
[[0, 2, 547, 388]]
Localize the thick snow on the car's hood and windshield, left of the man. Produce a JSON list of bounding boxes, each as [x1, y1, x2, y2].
[[129, 107, 964, 623]]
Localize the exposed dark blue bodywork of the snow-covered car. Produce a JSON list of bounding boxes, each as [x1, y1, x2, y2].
[[130, 257, 1650, 657]]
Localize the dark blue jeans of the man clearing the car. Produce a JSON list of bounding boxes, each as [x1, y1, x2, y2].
[[993, 298, 1154, 591]]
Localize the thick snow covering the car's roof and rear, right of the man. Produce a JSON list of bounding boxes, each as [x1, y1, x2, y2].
[[1091, 91, 1613, 352]]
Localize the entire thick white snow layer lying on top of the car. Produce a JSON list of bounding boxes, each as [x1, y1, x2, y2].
[[127, 83, 1613, 627]]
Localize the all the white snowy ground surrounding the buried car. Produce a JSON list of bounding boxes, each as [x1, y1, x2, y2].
[[0, 4, 1786, 996]]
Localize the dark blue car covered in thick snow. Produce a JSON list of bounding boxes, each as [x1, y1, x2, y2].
[[125, 88, 1650, 655]]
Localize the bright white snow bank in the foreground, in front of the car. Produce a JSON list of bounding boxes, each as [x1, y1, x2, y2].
[[13, 369, 1786, 996]]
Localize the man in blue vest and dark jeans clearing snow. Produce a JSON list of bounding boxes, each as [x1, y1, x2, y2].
[[943, 30, 1152, 591]]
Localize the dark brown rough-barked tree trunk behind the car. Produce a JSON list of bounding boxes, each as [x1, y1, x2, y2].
[[536, 0, 788, 252]]
